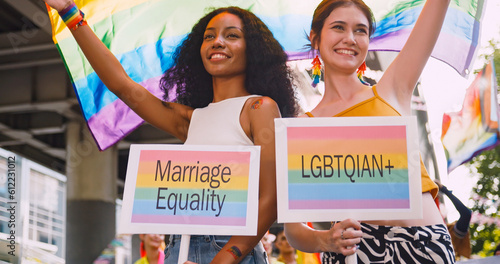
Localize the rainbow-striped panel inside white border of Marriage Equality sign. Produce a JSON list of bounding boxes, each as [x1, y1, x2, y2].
[[131, 150, 250, 227]]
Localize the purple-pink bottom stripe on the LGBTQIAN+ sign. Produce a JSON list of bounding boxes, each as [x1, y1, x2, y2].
[[288, 199, 410, 210]]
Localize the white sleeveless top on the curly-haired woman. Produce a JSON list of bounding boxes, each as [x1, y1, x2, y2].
[[184, 95, 259, 146]]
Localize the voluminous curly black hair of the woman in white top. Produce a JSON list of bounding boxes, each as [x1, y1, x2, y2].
[[160, 6, 298, 117]]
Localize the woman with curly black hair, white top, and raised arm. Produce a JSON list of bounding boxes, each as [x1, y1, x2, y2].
[[45, 0, 297, 263]]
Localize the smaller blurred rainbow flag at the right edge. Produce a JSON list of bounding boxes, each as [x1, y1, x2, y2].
[[441, 61, 500, 172]]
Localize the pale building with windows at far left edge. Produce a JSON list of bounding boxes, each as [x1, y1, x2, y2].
[[0, 149, 66, 264]]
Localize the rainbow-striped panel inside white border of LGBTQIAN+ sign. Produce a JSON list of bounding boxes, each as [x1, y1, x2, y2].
[[287, 125, 410, 210]]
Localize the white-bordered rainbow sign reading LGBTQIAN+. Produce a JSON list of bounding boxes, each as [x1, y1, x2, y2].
[[275, 117, 422, 223]]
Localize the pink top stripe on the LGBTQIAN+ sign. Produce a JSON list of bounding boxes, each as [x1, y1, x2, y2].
[[287, 126, 406, 140]]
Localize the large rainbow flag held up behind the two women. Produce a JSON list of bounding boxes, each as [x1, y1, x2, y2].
[[49, 0, 484, 150]]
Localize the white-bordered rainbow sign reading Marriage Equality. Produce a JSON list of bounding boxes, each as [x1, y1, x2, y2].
[[119, 145, 260, 235]]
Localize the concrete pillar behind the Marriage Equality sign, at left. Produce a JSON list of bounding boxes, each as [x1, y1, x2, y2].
[[66, 121, 118, 264]]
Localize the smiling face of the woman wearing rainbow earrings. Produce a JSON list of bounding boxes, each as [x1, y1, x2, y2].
[[311, 5, 370, 73]]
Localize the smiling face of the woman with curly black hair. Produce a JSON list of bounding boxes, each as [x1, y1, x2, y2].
[[200, 12, 247, 77]]
